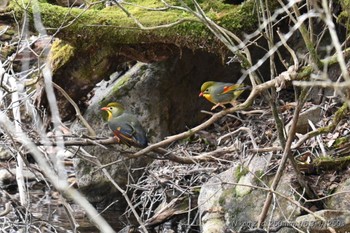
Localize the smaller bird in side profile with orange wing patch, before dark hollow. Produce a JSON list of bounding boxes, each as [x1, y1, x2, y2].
[[199, 81, 248, 110]]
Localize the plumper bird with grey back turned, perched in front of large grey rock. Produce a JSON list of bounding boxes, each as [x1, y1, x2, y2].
[[101, 102, 148, 148]]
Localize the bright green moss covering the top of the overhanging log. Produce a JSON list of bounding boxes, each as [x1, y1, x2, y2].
[[7, 0, 270, 51]]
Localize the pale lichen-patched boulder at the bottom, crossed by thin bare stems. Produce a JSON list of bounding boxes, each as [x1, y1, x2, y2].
[[198, 157, 300, 233]]
